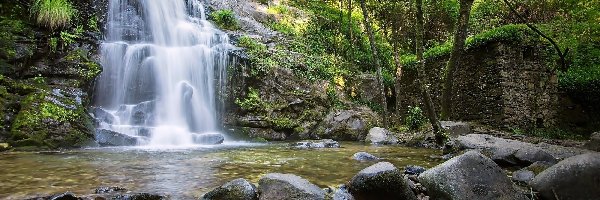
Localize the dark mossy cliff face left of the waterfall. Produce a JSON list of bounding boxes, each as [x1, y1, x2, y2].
[[0, 1, 105, 149]]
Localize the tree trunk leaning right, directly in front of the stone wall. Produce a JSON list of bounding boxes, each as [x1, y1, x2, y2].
[[442, 0, 473, 120]]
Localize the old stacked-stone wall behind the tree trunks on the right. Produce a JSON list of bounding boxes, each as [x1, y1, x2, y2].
[[396, 42, 558, 129]]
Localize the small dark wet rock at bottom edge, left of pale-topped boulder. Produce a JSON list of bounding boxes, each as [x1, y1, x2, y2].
[[200, 178, 258, 200]]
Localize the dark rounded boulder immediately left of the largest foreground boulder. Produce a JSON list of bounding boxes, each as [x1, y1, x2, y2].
[[348, 162, 416, 200]]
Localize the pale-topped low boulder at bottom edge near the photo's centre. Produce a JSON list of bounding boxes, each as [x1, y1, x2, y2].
[[258, 173, 325, 200]]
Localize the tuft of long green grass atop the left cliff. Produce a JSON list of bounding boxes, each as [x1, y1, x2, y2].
[[31, 0, 77, 29]]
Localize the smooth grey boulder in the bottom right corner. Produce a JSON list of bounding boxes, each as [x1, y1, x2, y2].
[[531, 153, 600, 199]]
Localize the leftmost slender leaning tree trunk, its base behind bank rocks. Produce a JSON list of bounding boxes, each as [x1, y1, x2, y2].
[[360, 0, 388, 128]]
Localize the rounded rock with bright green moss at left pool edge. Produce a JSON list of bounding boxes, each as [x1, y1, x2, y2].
[[9, 88, 93, 149]]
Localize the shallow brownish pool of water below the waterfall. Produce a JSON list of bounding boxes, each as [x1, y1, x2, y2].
[[0, 143, 442, 199]]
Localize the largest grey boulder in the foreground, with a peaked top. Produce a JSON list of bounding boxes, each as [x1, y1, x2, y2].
[[419, 151, 528, 200]]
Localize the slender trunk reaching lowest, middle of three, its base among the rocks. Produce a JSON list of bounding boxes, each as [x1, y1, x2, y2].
[[415, 0, 446, 146]]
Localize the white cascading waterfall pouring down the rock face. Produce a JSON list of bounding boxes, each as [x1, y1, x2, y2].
[[93, 0, 232, 146]]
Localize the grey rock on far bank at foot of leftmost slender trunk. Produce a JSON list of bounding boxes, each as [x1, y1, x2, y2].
[[320, 107, 381, 141]]
